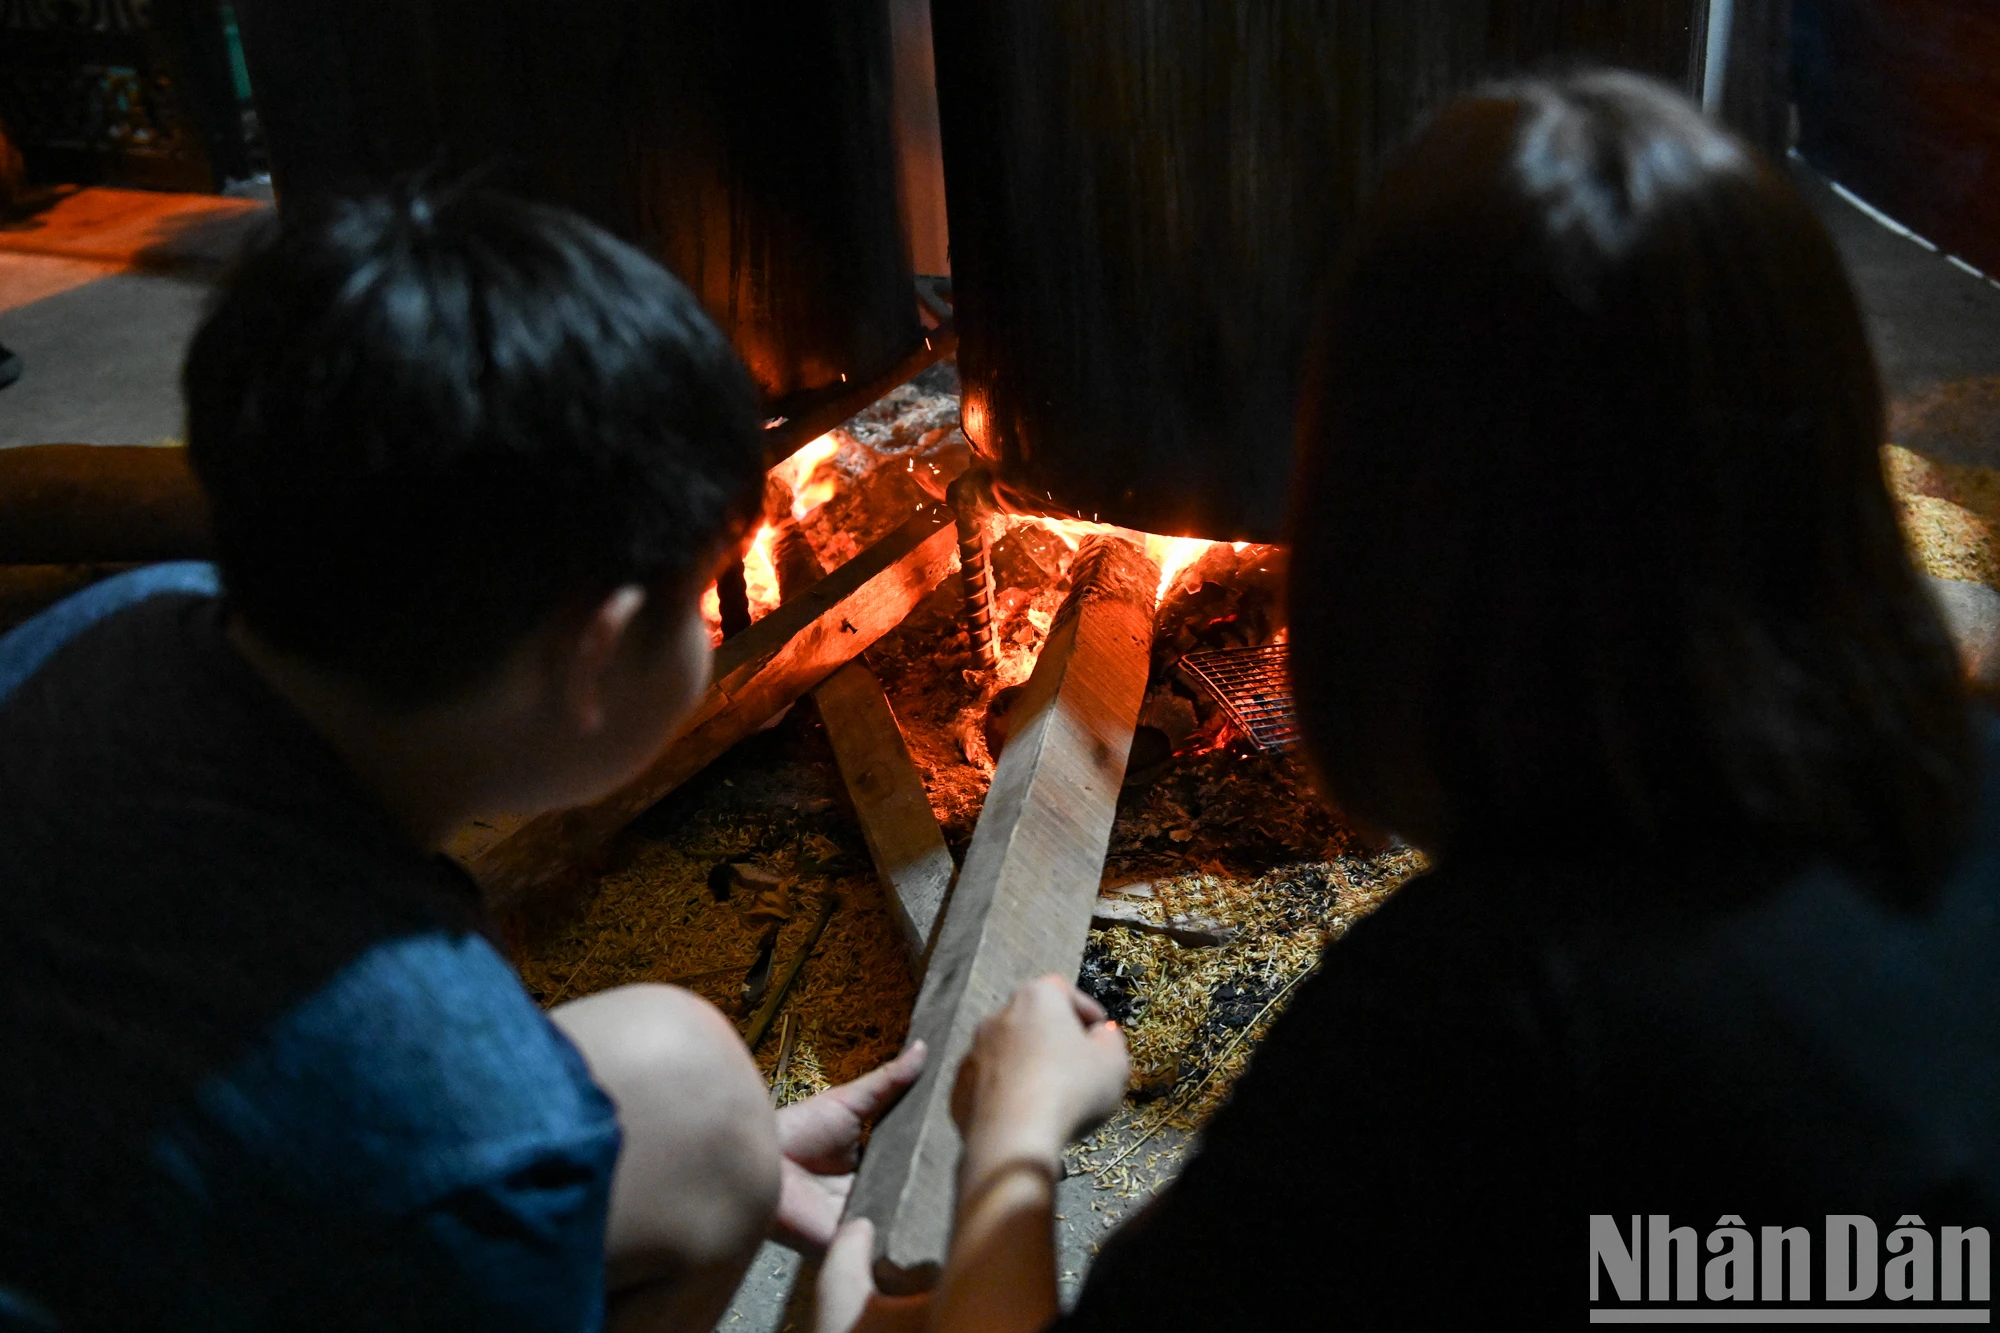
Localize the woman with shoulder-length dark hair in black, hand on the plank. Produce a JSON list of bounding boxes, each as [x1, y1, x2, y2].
[[868, 74, 2000, 1329]]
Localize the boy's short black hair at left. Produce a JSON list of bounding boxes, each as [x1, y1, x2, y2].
[[182, 184, 762, 705]]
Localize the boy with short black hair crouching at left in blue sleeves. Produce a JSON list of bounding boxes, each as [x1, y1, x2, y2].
[[0, 186, 922, 1329]]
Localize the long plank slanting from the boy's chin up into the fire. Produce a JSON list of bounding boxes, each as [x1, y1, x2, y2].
[[448, 506, 958, 903]]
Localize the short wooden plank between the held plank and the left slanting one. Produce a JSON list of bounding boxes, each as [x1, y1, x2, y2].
[[812, 662, 958, 964]]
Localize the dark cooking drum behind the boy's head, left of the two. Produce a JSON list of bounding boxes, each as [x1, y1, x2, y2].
[[238, 0, 918, 400]]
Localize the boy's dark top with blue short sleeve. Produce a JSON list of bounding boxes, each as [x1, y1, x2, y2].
[[0, 574, 618, 1329]]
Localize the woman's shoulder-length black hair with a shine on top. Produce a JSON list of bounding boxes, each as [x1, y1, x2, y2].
[[1290, 74, 1976, 903]]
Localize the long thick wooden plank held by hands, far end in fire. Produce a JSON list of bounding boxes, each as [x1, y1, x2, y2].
[[848, 536, 1160, 1293]]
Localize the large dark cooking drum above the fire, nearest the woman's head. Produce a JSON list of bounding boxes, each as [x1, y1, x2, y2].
[[932, 0, 1706, 540]]
